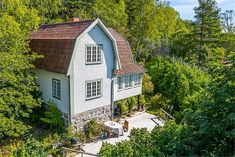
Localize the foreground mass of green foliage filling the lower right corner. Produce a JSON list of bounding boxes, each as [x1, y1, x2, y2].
[[101, 53, 235, 156]]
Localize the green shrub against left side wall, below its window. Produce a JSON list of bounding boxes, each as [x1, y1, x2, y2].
[[40, 103, 64, 131]]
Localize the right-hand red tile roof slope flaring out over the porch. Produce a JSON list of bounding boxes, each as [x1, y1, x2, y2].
[[108, 28, 144, 75]]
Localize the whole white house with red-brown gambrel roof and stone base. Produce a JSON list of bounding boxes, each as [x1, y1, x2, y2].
[[30, 19, 143, 126]]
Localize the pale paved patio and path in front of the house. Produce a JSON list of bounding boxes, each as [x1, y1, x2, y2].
[[76, 112, 164, 157]]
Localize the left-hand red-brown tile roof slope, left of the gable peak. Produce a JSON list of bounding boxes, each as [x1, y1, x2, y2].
[[29, 20, 94, 74]]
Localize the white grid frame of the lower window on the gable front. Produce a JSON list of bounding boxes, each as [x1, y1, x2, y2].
[[85, 79, 103, 100]]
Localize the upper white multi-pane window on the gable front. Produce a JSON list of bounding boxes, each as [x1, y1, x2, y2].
[[86, 45, 102, 64]]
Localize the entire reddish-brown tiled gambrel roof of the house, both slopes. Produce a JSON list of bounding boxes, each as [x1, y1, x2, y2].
[[30, 19, 143, 75]]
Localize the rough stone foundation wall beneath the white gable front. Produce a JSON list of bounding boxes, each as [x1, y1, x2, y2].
[[71, 105, 111, 131]]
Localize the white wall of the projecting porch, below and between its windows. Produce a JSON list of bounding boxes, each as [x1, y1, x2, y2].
[[114, 74, 142, 101]]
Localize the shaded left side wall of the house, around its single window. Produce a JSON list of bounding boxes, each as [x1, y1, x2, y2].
[[33, 69, 69, 114]]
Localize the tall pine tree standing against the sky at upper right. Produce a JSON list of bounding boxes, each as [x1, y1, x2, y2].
[[194, 0, 221, 66]]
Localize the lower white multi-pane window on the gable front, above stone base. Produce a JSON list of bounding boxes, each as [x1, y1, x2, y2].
[[86, 80, 102, 99]]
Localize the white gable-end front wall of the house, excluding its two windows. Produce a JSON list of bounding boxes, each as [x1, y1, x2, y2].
[[68, 25, 115, 115]]
